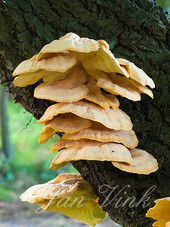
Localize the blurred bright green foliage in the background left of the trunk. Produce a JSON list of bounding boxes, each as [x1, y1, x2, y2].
[[0, 100, 77, 201]]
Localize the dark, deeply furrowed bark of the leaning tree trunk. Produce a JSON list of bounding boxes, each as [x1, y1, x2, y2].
[[0, 0, 170, 227]]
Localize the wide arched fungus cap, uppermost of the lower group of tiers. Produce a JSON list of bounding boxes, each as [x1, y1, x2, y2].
[[38, 101, 132, 131]]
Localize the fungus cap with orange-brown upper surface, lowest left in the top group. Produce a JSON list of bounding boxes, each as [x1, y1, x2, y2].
[[34, 67, 89, 102]]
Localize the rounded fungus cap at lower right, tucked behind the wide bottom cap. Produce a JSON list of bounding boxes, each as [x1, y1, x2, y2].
[[112, 148, 158, 174]]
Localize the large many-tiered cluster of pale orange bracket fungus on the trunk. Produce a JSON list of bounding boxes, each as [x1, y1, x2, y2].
[[13, 33, 158, 226]]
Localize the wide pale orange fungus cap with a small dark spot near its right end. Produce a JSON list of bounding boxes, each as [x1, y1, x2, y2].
[[50, 140, 133, 170]]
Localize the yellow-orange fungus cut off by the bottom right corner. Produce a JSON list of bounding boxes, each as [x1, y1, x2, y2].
[[146, 197, 170, 227]]
